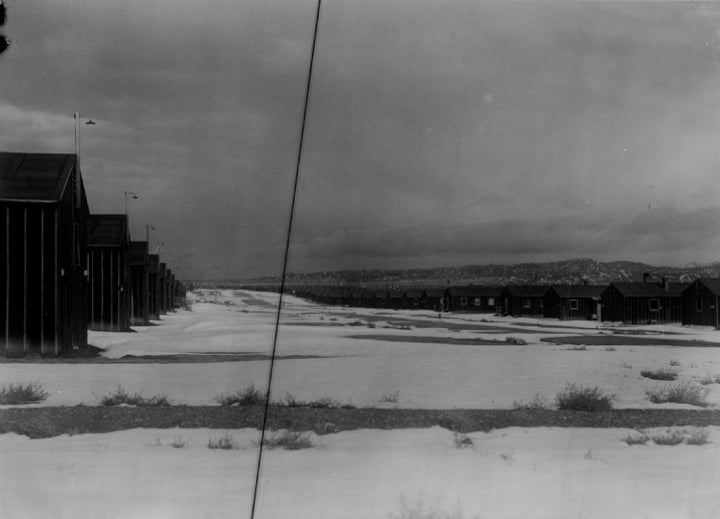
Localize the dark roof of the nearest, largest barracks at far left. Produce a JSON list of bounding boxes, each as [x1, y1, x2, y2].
[[0, 152, 76, 202]]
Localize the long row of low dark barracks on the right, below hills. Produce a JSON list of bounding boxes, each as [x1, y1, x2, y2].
[[282, 275, 720, 328]]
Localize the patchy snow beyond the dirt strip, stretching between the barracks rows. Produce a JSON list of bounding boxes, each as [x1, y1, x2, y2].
[[0, 291, 720, 409]]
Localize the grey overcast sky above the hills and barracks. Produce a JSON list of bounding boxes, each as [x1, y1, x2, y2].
[[0, 0, 720, 279]]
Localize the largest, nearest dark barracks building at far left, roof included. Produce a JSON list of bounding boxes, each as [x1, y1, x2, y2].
[[0, 152, 88, 356]]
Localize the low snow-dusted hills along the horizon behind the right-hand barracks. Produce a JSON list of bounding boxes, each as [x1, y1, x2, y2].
[[239, 258, 720, 286]]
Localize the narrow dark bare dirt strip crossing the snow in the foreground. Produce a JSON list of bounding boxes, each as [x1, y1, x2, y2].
[[0, 406, 720, 438]]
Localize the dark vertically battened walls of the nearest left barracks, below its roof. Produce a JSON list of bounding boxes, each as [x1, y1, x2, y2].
[[0, 171, 88, 356]]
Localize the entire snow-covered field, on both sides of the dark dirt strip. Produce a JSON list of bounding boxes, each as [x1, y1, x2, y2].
[[0, 291, 720, 519]]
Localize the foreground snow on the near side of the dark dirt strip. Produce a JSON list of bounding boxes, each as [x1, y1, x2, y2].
[[0, 427, 720, 519]]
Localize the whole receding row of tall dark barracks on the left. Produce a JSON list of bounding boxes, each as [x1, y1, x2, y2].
[[0, 152, 185, 356]]
